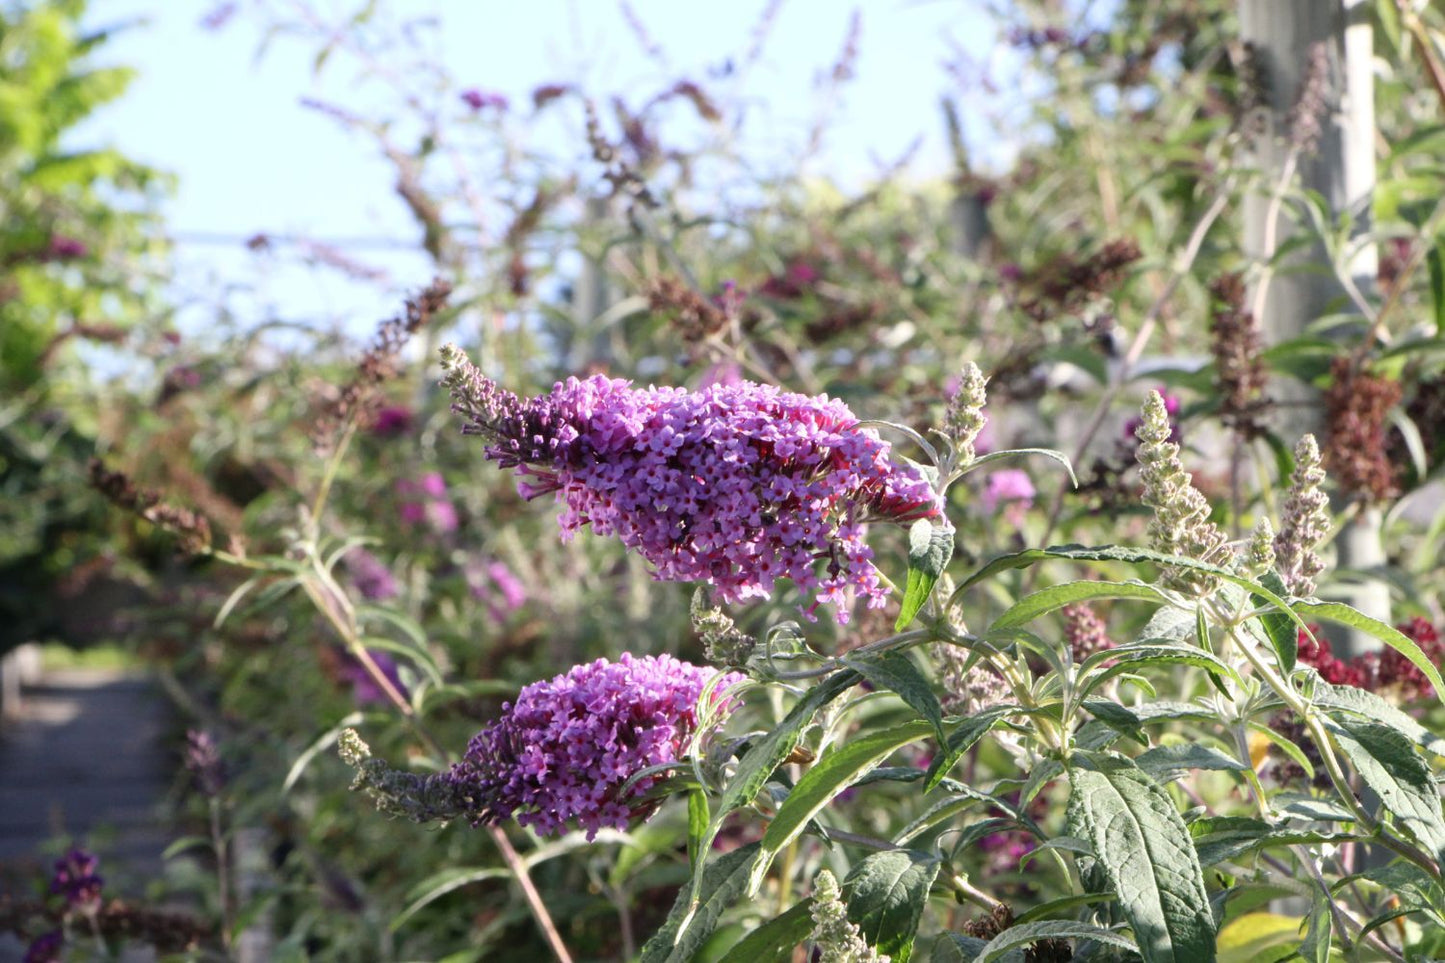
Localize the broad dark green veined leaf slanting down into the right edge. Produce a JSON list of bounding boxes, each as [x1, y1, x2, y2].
[[1328, 713, 1445, 865]]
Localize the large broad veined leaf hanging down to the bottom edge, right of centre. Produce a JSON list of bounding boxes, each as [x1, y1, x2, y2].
[[1068, 752, 1215, 963]]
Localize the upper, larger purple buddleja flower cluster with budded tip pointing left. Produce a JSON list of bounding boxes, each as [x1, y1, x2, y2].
[[442, 346, 941, 622]]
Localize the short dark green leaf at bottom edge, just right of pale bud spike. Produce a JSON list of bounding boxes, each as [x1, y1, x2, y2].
[[842, 849, 941, 963]]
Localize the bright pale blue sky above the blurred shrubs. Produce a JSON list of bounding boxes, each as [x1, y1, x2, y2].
[[81, 0, 994, 330]]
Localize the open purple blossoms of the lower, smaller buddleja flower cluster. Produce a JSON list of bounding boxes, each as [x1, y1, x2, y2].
[[449, 654, 743, 839]]
